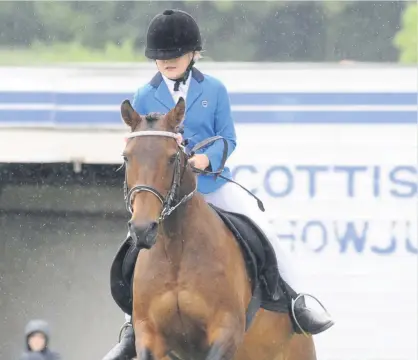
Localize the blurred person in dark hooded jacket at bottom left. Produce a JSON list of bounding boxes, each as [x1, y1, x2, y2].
[[20, 320, 61, 360]]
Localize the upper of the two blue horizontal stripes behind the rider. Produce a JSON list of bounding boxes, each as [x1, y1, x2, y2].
[[0, 91, 418, 105]]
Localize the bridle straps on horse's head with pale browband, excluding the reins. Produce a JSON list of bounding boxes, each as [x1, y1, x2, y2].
[[124, 130, 197, 223]]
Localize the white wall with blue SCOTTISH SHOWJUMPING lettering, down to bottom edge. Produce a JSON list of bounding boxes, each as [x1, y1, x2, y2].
[[229, 124, 418, 360]]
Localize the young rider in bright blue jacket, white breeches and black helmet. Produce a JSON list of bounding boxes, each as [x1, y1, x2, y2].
[[104, 10, 334, 360]]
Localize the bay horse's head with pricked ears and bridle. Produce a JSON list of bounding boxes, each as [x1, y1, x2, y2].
[[121, 98, 196, 248]]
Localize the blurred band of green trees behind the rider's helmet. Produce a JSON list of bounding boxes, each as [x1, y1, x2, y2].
[[0, 0, 408, 63]]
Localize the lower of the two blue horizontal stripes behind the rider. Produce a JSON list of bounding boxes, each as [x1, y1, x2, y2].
[[0, 110, 417, 126]]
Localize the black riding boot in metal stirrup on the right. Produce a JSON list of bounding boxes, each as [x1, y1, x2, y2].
[[281, 280, 335, 335]]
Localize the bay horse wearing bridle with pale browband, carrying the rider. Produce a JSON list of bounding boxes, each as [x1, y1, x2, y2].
[[121, 98, 316, 360]]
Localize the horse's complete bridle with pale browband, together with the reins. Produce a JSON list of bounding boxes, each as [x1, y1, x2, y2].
[[122, 130, 265, 223]]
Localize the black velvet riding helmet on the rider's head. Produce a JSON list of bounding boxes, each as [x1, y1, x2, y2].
[[145, 10, 202, 60]]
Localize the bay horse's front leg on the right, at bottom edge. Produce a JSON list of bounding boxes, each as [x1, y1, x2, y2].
[[206, 312, 244, 360]]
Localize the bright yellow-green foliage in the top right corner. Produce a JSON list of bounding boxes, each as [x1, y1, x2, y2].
[[394, 4, 418, 64]]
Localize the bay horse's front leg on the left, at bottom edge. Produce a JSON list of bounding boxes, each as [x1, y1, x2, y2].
[[134, 321, 167, 360]]
